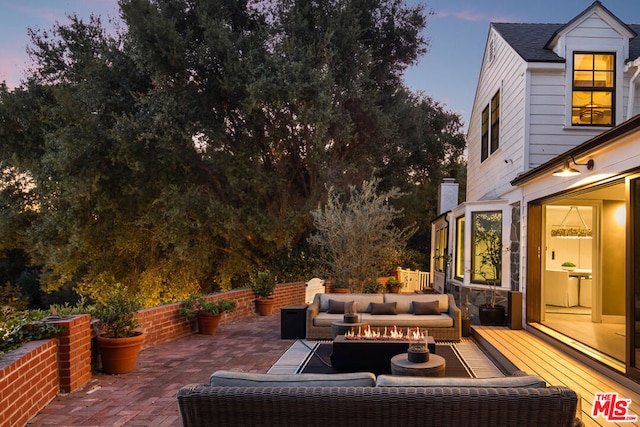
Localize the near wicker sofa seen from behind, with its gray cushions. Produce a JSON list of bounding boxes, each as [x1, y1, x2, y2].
[[177, 371, 583, 427]]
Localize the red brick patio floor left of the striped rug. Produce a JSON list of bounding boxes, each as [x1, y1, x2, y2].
[[27, 310, 295, 427]]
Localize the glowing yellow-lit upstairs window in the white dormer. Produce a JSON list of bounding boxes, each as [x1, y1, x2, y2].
[[571, 53, 616, 126]]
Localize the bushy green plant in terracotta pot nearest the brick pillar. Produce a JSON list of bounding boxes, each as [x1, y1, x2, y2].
[[92, 285, 145, 374]]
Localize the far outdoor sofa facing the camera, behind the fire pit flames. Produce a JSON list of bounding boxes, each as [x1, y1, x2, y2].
[[307, 294, 462, 341]]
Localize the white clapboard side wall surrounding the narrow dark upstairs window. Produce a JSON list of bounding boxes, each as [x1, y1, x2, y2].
[[467, 30, 526, 200]]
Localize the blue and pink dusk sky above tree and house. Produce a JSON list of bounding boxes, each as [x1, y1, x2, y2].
[[0, 0, 640, 125]]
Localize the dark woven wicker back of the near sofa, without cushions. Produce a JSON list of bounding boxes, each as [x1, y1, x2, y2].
[[177, 385, 582, 427]]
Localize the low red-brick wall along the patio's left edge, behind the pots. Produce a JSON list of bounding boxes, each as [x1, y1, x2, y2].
[[0, 282, 305, 426]]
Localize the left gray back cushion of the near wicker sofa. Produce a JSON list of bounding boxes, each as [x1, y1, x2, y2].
[[209, 371, 376, 387]]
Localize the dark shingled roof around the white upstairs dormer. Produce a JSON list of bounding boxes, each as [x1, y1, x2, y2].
[[491, 1, 640, 62]]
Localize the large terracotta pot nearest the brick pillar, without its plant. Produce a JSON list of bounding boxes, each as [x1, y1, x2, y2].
[[97, 332, 145, 374]]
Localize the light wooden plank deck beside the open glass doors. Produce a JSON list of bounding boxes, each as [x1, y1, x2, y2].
[[472, 325, 640, 426]]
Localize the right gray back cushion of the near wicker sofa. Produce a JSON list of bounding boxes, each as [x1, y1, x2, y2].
[[376, 375, 547, 388]]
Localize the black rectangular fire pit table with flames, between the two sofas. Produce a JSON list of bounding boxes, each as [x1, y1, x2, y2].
[[331, 335, 436, 375]]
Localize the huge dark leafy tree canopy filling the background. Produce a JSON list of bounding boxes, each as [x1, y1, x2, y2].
[[0, 0, 464, 304]]
